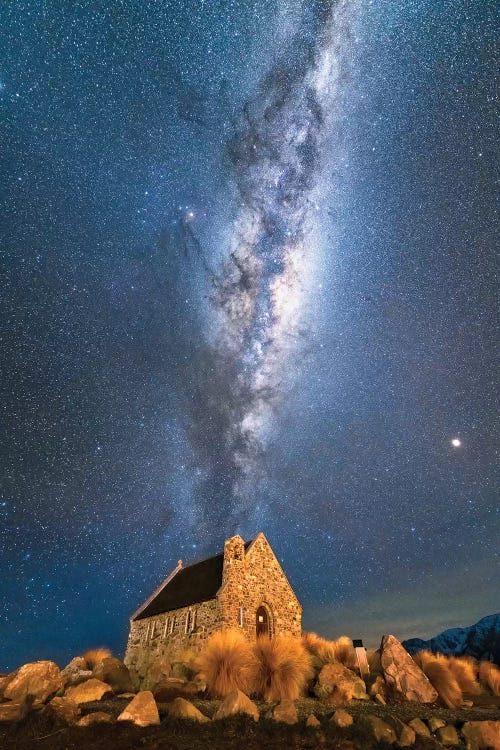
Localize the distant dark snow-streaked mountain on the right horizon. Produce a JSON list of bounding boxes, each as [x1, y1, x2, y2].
[[403, 613, 500, 665]]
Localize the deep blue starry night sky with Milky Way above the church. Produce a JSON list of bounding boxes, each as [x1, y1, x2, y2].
[[0, 0, 500, 671]]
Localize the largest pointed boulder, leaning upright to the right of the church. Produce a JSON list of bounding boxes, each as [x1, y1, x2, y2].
[[380, 635, 438, 703]]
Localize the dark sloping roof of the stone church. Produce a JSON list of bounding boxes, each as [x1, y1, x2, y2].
[[133, 540, 253, 620]]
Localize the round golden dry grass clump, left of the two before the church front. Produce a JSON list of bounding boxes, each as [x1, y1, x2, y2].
[[196, 630, 257, 698]]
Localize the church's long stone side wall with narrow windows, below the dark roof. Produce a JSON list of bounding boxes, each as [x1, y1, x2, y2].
[[124, 599, 221, 687]]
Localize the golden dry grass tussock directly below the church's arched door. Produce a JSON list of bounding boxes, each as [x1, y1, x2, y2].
[[254, 634, 313, 702]]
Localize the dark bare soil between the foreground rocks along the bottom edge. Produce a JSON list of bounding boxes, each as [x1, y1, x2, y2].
[[0, 696, 500, 750]]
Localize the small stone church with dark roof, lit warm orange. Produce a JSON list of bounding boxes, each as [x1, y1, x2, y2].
[[125, 533, 302, 679]]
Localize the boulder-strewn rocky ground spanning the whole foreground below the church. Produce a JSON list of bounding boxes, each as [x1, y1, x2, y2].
[[0, 637, 500, 750]]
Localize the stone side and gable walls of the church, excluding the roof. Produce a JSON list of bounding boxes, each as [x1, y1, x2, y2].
[[125, 533, 302, 684]]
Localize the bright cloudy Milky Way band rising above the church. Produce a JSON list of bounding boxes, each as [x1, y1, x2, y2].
[[188, 2, 354, 531]]
